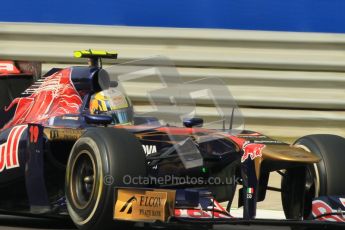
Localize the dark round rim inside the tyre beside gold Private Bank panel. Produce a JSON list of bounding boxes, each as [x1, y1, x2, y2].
[[70, 150, 96, 209]]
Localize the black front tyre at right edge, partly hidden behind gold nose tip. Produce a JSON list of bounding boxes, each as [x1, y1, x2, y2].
[[281, 134, 345, 219]]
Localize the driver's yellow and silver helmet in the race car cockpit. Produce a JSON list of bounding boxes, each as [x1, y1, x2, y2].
[[89, 88, 133, 125]]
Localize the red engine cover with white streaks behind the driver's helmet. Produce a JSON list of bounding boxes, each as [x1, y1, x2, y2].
[[3, 69, 82, 129]]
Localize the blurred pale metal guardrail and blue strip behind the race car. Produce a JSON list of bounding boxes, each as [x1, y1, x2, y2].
[[0, 0, 345, 142]]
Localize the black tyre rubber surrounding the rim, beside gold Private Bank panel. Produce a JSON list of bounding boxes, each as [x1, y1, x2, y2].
[[66, 128, 146, 230]]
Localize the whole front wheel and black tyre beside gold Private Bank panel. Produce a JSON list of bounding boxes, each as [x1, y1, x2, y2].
[[65, 128, 146, 230]]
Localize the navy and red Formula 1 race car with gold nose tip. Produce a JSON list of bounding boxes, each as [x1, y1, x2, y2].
[[0, 50, 345, 229]]
